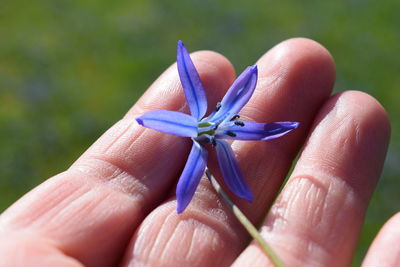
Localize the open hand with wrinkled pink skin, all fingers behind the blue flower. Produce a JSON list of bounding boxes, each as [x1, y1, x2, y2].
[[0, 38, 394, 267]]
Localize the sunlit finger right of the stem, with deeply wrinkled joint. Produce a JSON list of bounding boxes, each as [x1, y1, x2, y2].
[[236, 91, 390, 266]]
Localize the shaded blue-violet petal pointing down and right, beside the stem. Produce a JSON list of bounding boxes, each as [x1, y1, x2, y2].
[[215, 140, 253, 202]]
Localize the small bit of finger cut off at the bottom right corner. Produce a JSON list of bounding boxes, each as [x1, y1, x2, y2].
[[362, 213, 400, 267]]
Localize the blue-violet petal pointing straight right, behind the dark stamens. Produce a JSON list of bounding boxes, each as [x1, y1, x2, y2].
[[216, 121, 299, 140]]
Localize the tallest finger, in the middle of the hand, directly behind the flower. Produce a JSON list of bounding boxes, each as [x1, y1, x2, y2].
[[125, 39, 334, 266]]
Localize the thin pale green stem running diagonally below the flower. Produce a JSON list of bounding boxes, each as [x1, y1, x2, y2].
[[206, 169, 285, 267]]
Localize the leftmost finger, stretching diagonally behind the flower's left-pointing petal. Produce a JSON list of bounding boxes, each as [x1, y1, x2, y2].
[[0, 51, 234, 266]]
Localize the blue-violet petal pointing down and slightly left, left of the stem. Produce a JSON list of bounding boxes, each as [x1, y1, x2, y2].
[[176, 141, 208, 213]]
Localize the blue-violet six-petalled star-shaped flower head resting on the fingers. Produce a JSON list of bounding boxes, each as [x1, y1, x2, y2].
[[136, 41, 299, 213]]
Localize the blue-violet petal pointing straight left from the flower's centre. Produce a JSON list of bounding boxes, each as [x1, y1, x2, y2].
[[136, 110, 197, 137]]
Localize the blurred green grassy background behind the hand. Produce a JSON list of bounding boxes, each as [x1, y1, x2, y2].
[[0, 0, 400, 265]]
